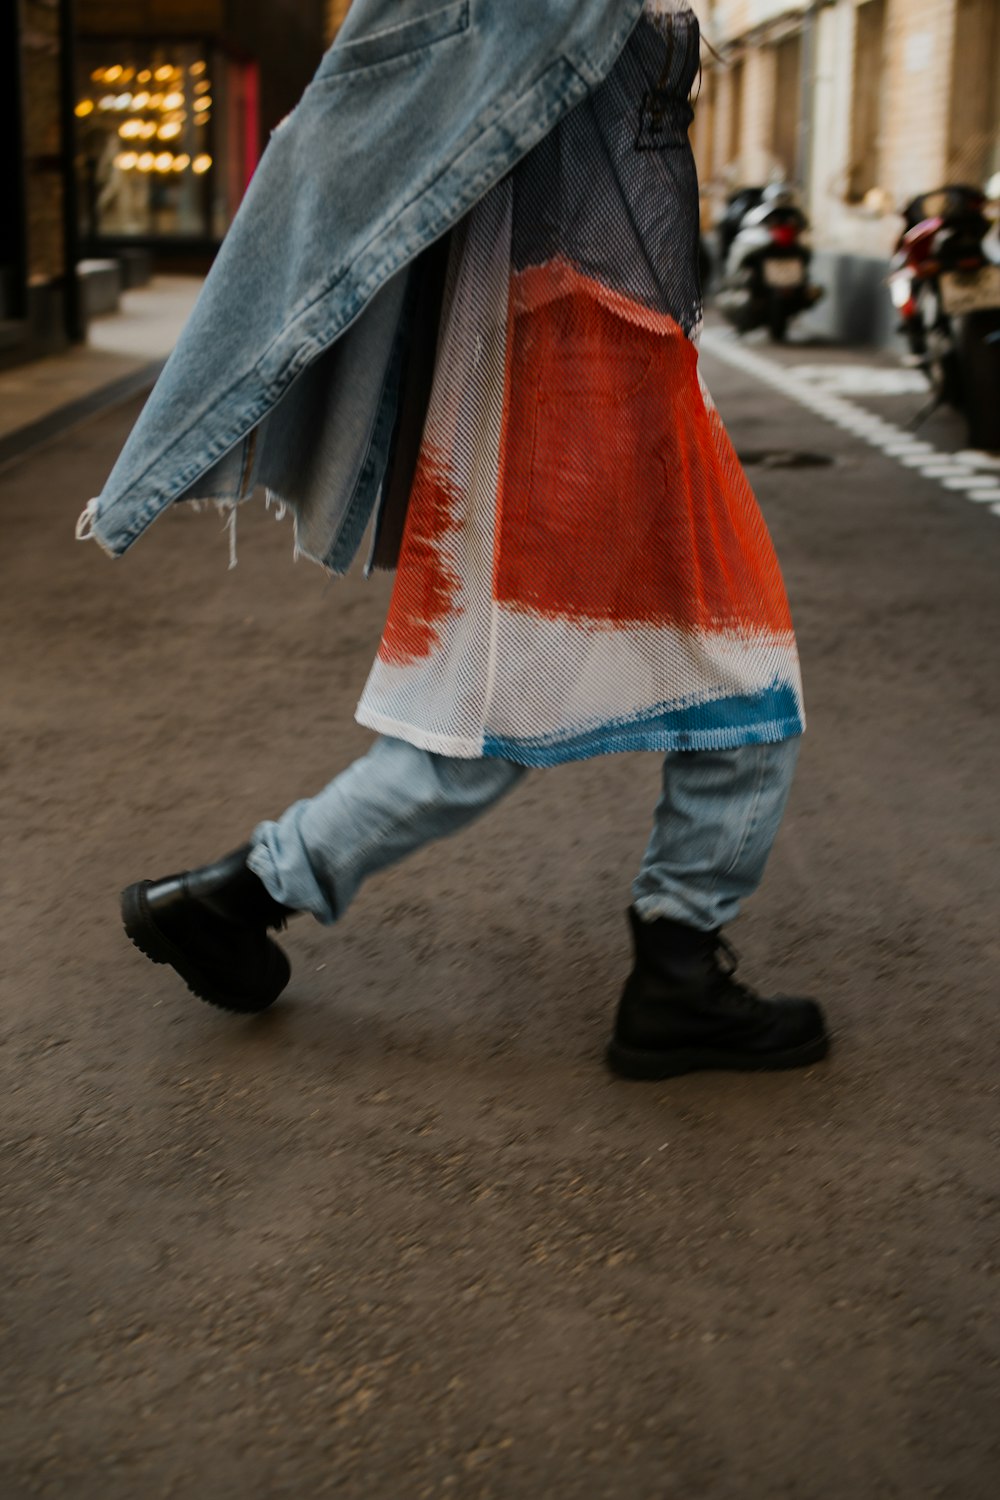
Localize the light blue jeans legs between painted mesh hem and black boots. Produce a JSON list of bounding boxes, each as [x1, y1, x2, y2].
[[247, 738, 799, 932]]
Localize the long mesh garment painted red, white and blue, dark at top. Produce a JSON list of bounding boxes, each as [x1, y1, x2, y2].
[[358, 8, 802, 765]]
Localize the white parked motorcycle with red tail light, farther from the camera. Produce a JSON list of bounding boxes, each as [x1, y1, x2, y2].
[[715, 183, 823, 344]]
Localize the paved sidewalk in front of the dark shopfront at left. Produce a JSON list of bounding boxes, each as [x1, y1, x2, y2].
[[0, 276, 202, 465]]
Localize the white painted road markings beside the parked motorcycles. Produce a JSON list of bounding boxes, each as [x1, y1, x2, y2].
[[699, 329, 1000, 518]]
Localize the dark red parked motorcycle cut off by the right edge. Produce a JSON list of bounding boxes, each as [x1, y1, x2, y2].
[[889, 185, 1000, 449]]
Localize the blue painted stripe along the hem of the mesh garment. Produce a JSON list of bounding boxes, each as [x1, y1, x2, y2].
[[483, 678, 804, 767]]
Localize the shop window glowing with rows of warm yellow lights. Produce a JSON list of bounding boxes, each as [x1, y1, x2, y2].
[[76, 39, 258, 242]]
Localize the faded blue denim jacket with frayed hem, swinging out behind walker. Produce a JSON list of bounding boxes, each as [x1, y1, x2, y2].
[[78, 0, 643, 572]]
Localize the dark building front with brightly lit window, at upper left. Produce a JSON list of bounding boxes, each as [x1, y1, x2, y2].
[[0, 0, 329, 368]]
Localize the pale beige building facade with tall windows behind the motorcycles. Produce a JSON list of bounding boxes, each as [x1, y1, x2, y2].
[[694, 0, 1000, 342]]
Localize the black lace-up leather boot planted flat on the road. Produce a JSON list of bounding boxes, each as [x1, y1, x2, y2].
[[607, 909, 829, 1079]]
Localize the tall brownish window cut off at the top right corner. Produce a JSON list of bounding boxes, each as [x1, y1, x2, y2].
[[948, 0, 1000, 186]]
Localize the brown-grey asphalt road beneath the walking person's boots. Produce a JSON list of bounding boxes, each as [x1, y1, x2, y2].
[[0, 340, 1000, 1500]]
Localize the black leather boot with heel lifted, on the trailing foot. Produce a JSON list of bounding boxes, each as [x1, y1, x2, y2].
[[121, 845, 292, 1011]]
